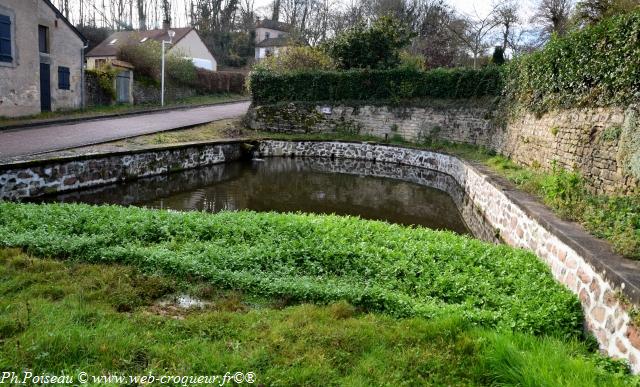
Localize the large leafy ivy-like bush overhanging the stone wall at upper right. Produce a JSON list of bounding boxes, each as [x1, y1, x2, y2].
[[506, 12, 640, 113]]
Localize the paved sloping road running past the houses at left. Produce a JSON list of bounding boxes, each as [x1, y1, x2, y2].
[[0, 102, 249, 160]]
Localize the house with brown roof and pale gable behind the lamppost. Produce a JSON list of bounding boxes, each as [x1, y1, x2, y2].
[[87, 26, 218, 71]]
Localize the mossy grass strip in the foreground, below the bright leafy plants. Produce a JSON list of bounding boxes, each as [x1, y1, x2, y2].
[[0, 249, 637, 387]]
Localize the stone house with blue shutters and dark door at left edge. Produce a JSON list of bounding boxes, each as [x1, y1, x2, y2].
[[0, 0, 86, 117]]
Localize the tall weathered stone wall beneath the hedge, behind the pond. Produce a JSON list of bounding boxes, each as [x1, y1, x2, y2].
[[248, 100, 640, 193]]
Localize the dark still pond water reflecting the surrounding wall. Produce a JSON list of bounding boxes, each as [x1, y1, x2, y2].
[[37, 158, 470, 234]]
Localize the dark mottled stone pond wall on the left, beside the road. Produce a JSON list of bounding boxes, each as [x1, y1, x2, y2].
[[0, 142, 242, 200]]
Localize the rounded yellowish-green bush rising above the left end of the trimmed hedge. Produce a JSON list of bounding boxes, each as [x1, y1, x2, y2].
[[253, 47, 336, 73]]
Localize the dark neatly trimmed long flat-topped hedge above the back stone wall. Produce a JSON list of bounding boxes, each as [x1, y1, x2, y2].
[[251, 67, 502, 103]]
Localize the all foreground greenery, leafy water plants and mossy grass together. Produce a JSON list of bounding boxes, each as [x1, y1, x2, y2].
[[0, 209, 637, 386]]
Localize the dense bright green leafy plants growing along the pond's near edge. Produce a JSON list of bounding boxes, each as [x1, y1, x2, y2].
[[0, 203, 582, 337]]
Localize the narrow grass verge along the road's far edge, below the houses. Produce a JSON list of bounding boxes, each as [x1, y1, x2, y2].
[[0, 94, 246, 128]]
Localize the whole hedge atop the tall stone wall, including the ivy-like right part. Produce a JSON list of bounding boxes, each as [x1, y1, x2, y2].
[[251, 11, 640, 113]]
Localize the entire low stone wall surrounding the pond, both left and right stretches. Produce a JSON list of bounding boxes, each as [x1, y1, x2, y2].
[[0, 140, 640, 373]]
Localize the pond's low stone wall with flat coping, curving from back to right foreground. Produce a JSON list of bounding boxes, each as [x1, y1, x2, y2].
[[258, 141, 640, 373]]
